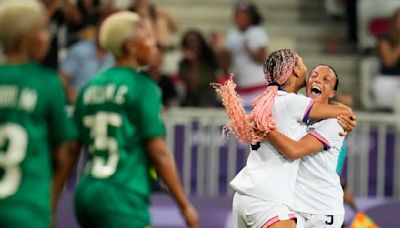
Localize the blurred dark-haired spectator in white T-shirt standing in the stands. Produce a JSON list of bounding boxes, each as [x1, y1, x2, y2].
[[226, 1, 268, 110]]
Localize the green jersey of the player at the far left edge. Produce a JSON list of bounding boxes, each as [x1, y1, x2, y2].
[[0, 63, 74, 226]]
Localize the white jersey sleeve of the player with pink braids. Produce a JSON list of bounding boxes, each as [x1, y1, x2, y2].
[[285, 93, 314, 123]]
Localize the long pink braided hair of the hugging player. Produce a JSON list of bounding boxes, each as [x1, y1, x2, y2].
[[212, 49, 298, 144]]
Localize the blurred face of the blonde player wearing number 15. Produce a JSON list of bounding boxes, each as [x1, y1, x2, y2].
[[136, 19, 157, 66]]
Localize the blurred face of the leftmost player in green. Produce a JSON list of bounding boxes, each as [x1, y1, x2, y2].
[[25, 16, 50, 61]]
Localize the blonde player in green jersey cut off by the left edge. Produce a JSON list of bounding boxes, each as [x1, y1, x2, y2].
[[0, 0, 78, 228]]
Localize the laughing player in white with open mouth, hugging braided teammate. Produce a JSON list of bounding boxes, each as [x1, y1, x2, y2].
[[267, 65, 352, 228]]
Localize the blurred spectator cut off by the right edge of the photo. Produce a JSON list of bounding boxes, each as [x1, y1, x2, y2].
[[374, 9, 400, 109]]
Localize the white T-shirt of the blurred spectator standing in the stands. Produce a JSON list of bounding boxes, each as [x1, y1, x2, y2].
[[226, 26, 268, 88]]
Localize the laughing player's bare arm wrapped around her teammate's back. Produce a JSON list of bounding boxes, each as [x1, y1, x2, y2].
[[266, 130, 324, 160]]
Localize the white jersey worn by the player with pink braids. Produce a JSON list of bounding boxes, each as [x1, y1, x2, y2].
[[231, 91, 314, 207]]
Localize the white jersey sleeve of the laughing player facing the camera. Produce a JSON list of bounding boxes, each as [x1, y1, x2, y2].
[[308, 118, 344, 150]]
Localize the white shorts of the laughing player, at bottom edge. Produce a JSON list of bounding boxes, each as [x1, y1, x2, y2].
[[296, 212, 344, 228]]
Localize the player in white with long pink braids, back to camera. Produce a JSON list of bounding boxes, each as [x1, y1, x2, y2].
[[216, 49, 353, 228]]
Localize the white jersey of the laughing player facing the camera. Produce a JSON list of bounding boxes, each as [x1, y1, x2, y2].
[[294, 119, 344, 215]]
